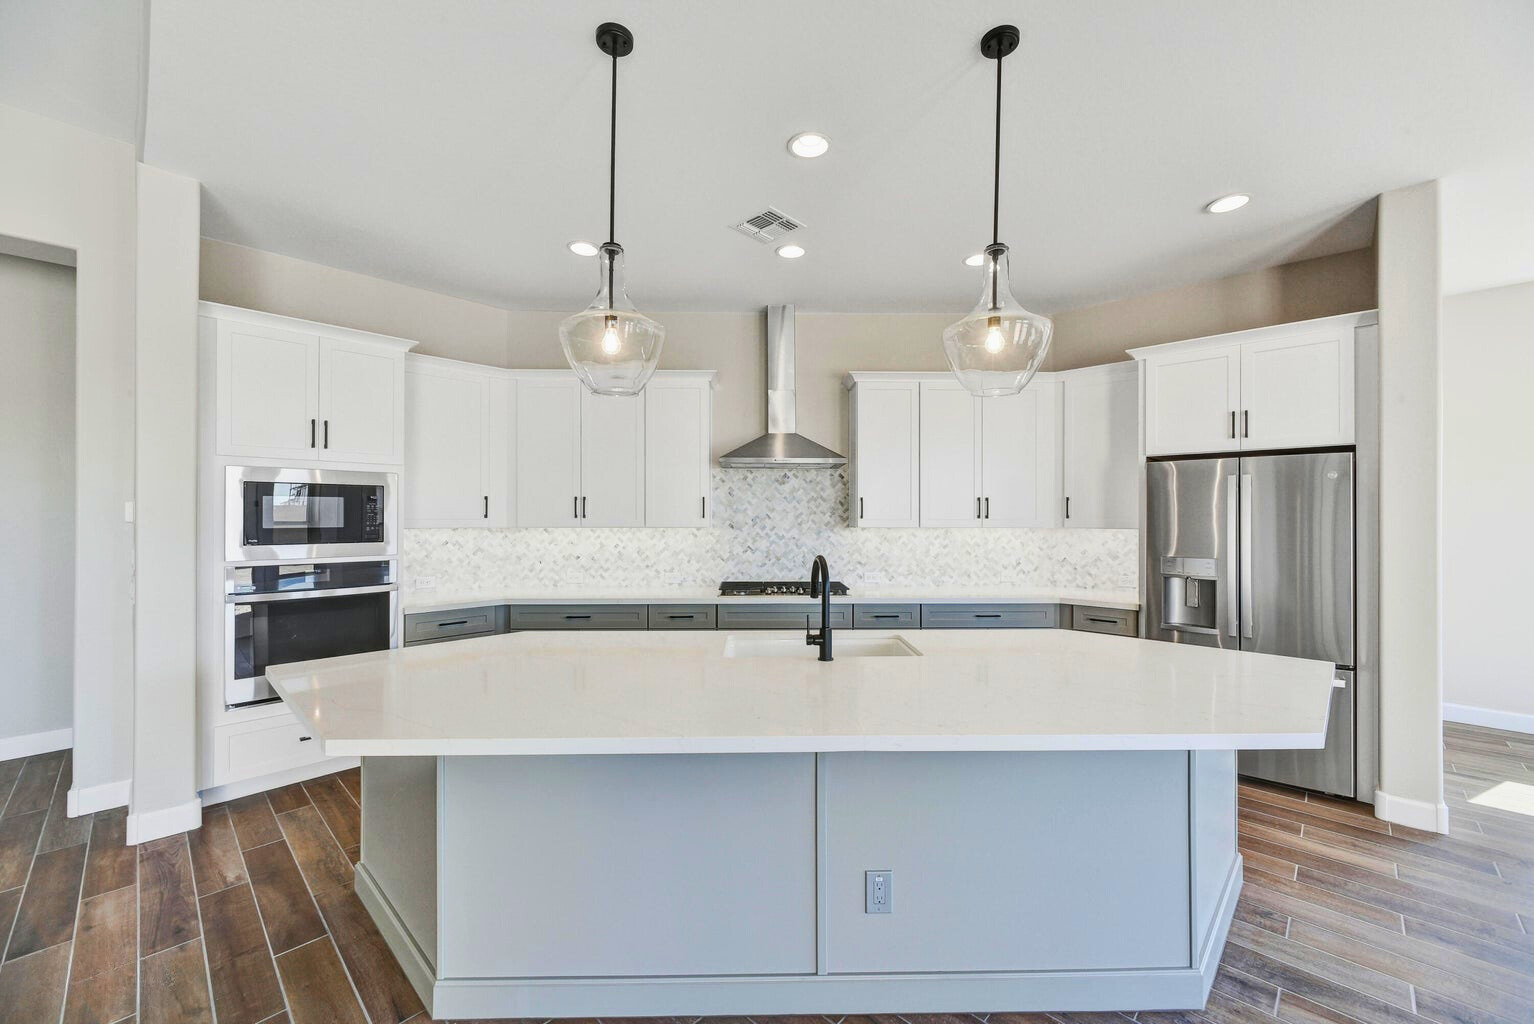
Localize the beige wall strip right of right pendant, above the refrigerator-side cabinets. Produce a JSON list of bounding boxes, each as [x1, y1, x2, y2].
[[1046, 248, 1376, 369]]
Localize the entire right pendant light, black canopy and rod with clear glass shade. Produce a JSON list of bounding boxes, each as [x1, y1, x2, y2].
[[943, 25, 1054, 399]]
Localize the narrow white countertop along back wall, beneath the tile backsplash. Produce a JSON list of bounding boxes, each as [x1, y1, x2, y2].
[[402, 587, 1140, 613]]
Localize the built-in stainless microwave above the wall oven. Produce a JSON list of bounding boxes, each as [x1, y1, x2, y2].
[[224, 466, 399, 561]]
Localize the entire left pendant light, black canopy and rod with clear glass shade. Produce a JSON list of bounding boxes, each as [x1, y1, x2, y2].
[[560, 21, 666, 395]]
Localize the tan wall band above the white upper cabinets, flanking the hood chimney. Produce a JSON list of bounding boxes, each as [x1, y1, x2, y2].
[[202, 239, 1374, 455]]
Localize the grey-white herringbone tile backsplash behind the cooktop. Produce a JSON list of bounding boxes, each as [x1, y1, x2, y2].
[[403, 469, 1138, 593]]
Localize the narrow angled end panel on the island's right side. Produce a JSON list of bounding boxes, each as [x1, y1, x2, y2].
[[1189, 750, 1239, 963]]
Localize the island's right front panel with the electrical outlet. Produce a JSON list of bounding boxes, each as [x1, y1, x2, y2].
[[821, 751, 1190, 974]]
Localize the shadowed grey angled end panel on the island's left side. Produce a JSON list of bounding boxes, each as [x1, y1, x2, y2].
[[359, 757, 437, 981]]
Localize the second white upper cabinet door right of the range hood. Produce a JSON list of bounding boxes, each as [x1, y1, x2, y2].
[[922, 380, 982, 527]]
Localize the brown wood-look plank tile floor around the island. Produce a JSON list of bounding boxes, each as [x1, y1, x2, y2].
[[0, 725, 1534, 1024]]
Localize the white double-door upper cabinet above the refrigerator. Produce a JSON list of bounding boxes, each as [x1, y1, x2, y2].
[[1131, 313, 1378, 455]]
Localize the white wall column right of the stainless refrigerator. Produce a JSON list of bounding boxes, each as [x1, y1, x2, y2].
[[1374, 181, 1448, 832]]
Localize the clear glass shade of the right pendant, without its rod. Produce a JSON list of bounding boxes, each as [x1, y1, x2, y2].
[[943, 242, 1054, 399]]
